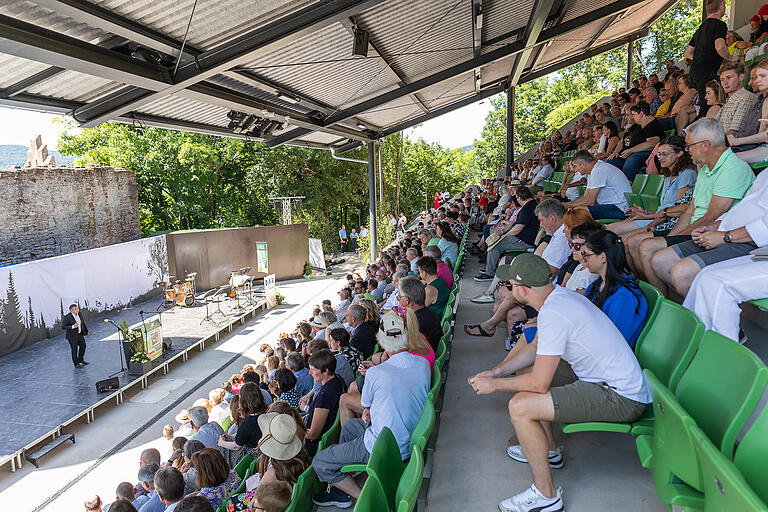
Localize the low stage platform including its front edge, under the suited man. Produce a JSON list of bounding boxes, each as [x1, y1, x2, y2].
[[0, 290, 267, 472]]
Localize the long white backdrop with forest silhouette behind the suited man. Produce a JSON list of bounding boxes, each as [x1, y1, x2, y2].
[[0, 236, 168, 356]]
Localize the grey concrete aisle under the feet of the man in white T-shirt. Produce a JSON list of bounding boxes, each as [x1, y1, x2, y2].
[[427, 241, 667, 512]]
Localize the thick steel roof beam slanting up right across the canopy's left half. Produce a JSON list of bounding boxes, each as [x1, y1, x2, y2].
[[73, 0, 382, 126]]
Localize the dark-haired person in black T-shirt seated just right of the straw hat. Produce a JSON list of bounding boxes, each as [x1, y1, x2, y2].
[[305, 349, 347, 455]]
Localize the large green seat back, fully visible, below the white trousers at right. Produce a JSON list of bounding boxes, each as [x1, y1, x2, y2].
[[675, 331, 768, 458]]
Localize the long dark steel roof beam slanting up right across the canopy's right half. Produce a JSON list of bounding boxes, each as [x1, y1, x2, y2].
[[323, 0, 643, 126]]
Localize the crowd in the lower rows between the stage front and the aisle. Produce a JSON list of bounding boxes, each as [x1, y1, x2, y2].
[[85, 192, 472, 512]]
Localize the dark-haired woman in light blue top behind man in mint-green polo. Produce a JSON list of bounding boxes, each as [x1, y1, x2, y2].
[[608, 135, 698, 234]]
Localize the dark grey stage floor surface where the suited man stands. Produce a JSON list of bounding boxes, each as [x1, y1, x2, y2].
[[0, 297, 260, 459]]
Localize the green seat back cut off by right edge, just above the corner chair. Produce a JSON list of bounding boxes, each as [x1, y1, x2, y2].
[[733, 401, 768, 504]]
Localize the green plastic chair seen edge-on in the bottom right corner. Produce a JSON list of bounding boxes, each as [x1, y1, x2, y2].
[[693, 428, 768, 512]]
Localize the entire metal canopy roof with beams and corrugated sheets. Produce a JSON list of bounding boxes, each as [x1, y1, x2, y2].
[[0, 0, 677, 150]]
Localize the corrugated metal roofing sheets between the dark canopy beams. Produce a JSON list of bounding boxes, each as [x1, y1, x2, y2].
[[0, 0, 671, 148]]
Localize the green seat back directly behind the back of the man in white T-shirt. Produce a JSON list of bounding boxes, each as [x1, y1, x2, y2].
[[635, 299, 704, 390]]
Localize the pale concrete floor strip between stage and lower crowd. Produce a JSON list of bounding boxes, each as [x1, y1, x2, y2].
[[0, 255, 359, 512]]
